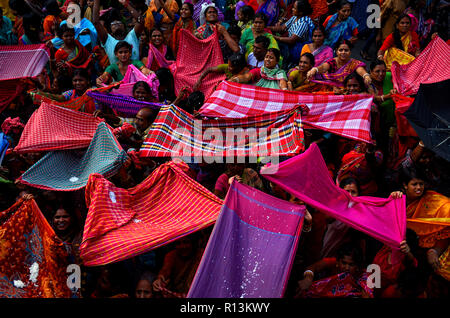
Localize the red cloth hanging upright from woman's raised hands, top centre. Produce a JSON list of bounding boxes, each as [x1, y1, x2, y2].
[[172, 29, 225, 98]]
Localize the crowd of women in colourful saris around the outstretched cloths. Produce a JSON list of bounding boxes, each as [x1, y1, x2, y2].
[[0, 0, 450, 298]]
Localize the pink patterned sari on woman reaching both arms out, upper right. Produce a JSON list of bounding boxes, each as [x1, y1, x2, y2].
[[311, 58, 366, 87]]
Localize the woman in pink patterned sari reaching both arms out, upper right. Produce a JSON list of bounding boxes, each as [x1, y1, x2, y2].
[[307, 40, 372, 92]]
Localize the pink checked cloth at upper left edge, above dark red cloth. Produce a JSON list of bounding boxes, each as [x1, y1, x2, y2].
[[0, 44, 50, 81]]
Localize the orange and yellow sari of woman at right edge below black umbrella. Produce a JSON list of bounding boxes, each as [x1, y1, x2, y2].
[[406, 190, 450, 281]]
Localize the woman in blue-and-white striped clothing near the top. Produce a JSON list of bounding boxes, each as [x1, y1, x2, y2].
[[269, 0, 314, 65]]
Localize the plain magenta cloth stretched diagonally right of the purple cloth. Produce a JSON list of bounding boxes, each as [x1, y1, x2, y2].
[[261, 144, 406, 251]]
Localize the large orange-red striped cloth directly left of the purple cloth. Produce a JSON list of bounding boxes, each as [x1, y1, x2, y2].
[[80, 161, 223, 266]]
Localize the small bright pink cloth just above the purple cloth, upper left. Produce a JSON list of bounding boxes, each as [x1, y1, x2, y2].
[[111, 64, 159, 99]]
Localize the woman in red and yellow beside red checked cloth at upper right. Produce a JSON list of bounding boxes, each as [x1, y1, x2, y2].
[[378, 14, 420, 69]]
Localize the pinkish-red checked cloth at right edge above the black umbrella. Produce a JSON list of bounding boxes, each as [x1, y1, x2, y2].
[[391, 36, 450, 96]]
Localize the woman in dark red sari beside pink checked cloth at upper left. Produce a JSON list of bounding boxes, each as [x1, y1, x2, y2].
[[55, 24, 92, 75]]
